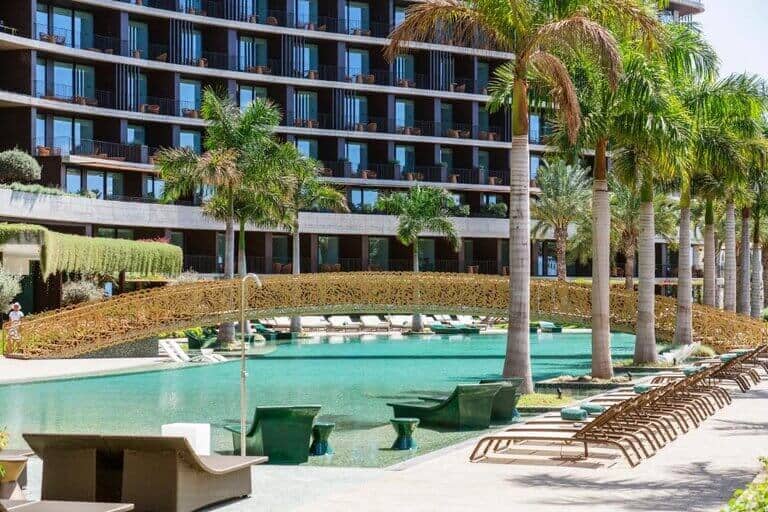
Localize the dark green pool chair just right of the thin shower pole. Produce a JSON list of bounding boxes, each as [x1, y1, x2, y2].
[[224, 405, 320, 464]]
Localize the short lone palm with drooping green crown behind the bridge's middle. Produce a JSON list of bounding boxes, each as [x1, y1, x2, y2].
[[376, 185, 459, 332]]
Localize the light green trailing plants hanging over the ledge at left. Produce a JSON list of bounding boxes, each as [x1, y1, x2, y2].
[[0, 224, 183, 277]]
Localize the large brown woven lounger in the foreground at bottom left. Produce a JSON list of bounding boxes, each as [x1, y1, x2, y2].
[[24, 434, 267, 512]]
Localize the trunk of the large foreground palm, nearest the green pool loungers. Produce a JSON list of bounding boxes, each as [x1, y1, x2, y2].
[[504, 77, 533, 393]]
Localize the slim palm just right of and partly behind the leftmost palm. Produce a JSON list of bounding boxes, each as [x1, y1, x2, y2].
[[284, 143, 349, 332]]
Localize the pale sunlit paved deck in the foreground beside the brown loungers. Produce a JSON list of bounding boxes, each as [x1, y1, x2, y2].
[[18, 372, 768, 512]]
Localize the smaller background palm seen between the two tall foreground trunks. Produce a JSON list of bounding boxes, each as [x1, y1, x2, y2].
[[531, 160, 591, 280]]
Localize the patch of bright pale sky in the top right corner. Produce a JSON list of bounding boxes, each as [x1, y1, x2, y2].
[[695, 0, 768, 79]]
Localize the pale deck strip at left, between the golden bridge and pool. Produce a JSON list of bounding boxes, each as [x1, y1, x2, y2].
[[0, 357, 171, 385]]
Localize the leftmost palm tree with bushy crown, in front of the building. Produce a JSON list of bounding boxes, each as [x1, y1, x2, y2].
[[155, 87, 280, 342]]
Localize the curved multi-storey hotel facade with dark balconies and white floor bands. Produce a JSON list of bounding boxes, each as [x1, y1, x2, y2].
[[0, 0, 703, 308]]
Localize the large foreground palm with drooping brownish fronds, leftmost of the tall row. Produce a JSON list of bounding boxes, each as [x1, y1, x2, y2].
[[386, 0, 640, 392]]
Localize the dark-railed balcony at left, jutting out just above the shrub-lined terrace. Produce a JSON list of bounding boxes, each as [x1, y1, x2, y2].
[[35, 137, 150, 164]]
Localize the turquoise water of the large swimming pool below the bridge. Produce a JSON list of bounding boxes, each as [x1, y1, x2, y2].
[[0, 334, 634, 466]]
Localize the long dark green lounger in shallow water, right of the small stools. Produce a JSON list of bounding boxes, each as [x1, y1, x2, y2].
[[387, 384, 502, 430]]
